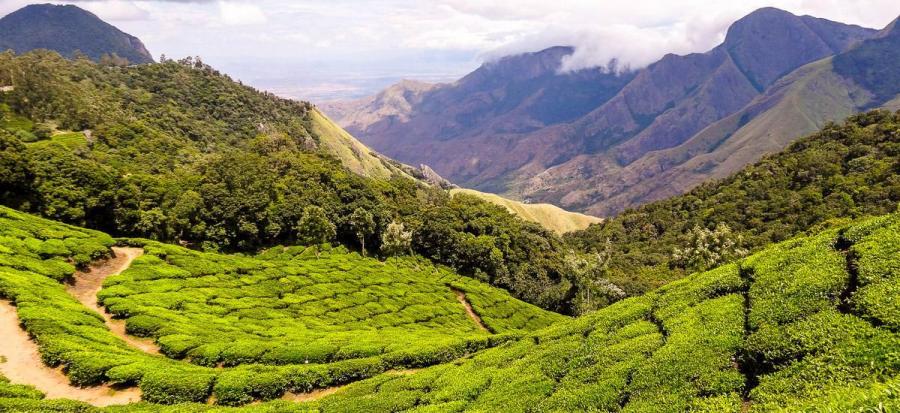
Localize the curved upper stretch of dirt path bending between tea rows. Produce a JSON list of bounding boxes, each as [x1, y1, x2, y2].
[[66, 247, 159, 354]]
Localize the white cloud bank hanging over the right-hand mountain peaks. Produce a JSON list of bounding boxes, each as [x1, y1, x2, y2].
[[468, 0, 900, 70]]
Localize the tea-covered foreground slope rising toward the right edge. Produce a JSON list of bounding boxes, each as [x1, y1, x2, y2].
[[312, 214, 900, 412]]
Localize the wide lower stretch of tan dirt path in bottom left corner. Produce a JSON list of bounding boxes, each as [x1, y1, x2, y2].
[[0, 300, 141, 406]]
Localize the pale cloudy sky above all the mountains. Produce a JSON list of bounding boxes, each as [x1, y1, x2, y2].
[[0, 0, 900, 101]]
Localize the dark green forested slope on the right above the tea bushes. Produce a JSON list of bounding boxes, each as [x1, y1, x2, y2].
[[566, 110, 900, 294]]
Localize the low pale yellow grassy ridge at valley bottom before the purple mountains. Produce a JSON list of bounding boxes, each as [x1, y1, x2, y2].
[[450, 188, 603, 234]]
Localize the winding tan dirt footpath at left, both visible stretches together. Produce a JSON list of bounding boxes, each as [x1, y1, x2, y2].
[[0, 248, 151, 406]]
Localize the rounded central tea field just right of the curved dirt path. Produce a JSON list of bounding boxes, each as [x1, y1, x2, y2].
[[99, 237, 562, 367]]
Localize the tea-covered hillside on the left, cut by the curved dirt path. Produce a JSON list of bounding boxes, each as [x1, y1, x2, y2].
[[0, 204, 564, 410]]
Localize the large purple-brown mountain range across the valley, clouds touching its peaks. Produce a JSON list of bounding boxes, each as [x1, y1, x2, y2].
[[325, 8, 884, 216]]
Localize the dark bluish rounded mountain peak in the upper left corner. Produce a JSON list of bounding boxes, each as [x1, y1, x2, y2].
[[0, 4, 153, 63]]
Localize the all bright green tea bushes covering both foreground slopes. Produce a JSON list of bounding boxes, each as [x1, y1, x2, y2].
[[0, 204, 900, 412]]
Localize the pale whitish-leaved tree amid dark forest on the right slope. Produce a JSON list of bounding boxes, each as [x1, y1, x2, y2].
[[672, 222, 748, 271]]
